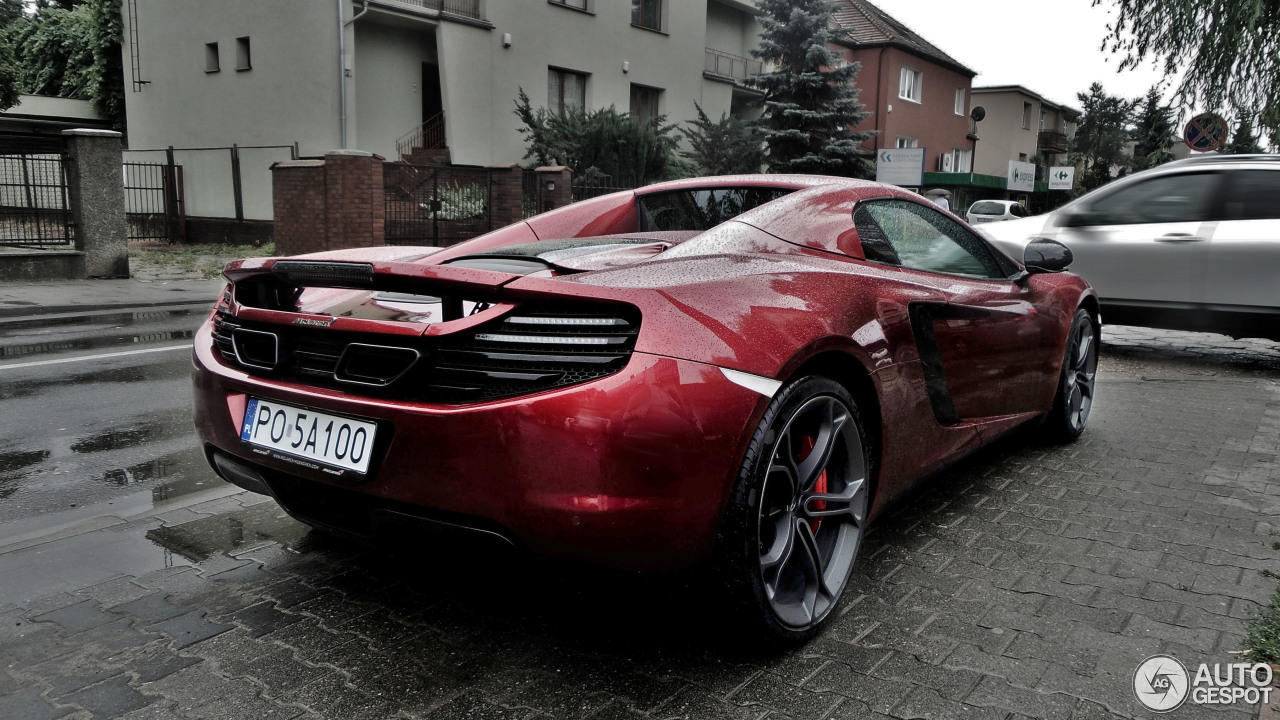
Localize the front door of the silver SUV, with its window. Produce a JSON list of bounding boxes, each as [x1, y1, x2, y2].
[[1055, 172, 1222, 305]]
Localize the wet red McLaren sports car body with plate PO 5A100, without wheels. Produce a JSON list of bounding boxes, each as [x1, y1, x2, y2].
[[195, 176, 1096, 632]]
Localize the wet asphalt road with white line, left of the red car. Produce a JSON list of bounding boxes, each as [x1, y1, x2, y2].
[[0, 307, 212, 520]]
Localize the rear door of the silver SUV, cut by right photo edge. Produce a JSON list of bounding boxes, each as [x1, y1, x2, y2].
[[1204, 168, 1280, 310]]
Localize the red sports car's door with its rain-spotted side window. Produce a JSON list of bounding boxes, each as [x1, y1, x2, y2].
[[854, 199, 1061, 424]]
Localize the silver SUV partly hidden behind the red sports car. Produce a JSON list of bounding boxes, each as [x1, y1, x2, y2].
[[982, 155, 1280, 340]]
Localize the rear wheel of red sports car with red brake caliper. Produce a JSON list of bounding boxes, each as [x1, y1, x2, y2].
[[714, 377, 874, 642]]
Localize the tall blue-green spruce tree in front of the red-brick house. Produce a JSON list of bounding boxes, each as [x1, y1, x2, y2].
[[748, 0, 874, 177]]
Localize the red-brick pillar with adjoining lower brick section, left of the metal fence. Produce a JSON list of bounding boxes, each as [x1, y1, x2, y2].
[[271, 150, 387, 255]]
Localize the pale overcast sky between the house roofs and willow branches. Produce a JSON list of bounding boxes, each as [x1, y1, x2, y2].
[[872, 0, 1170, 108]]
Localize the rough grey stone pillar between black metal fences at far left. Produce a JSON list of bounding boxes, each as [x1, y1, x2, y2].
[[63, 129, 129, 278]]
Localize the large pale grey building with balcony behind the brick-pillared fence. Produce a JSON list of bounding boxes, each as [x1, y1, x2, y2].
[[123, 0, 759, 219]]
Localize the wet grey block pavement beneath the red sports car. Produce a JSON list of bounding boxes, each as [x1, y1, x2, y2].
[[0, 328, 1280, 720]]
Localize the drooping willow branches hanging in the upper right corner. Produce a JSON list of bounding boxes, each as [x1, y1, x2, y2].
[[1093, 0, 1280, 132]]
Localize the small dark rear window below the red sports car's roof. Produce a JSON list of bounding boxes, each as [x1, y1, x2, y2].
[[640, 187, 795, 232]]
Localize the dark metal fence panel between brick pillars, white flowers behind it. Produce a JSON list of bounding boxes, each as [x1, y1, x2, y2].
[[383, 163, 493, 246]]
